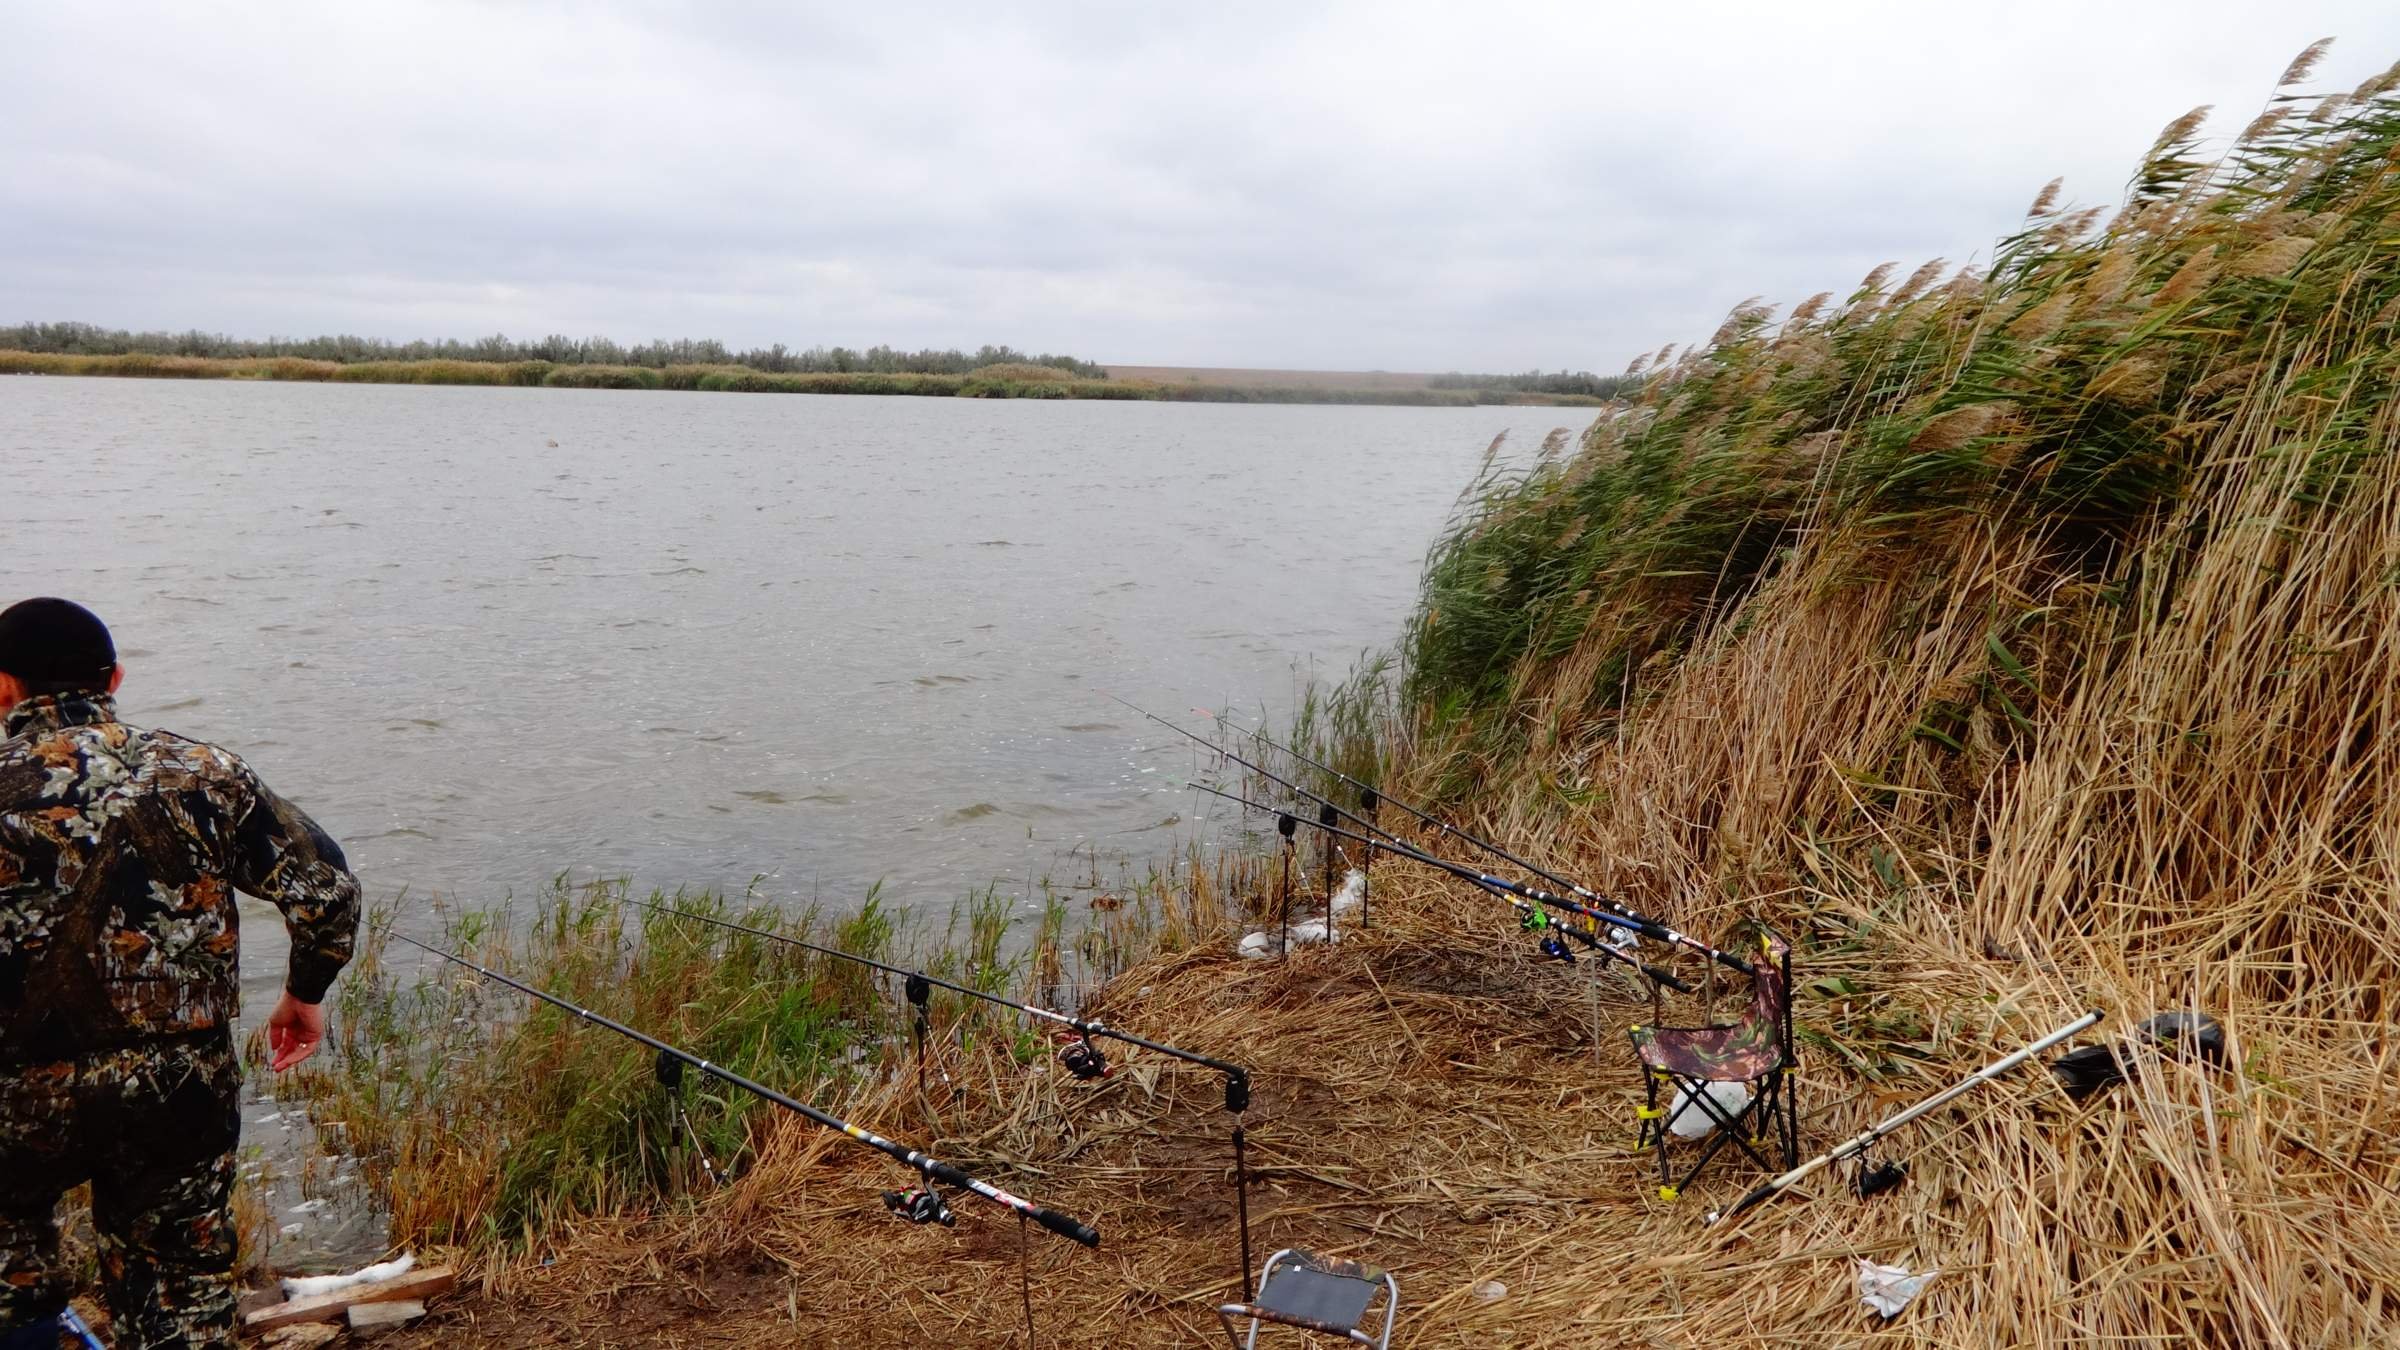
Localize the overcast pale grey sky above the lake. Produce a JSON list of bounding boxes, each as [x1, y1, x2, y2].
[[0, 0, 2400, 370]]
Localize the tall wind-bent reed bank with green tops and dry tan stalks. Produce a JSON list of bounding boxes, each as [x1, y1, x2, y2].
[[1324, 42, 2400, 1345]]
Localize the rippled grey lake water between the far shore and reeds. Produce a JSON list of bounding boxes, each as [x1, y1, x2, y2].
[[0, 377, 1589, 1258]]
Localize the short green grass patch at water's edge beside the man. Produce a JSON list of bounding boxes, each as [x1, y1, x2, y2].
[[298, 884, 878, 1247]]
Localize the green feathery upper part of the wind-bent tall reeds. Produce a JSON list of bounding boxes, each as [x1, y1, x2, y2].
[[1406, 49, 2400, 759]]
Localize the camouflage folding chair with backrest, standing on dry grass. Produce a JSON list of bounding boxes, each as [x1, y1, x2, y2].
[[1632, 922, 1800, 1201]]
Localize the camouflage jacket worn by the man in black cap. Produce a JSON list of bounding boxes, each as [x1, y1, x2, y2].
[[0, 694, 358, 1064]]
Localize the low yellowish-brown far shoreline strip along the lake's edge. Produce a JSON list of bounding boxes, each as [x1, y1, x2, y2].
[[0, 348, 1606, 408]]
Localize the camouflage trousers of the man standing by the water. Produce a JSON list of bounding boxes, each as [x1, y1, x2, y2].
[[0, 1033, 242, 1350]]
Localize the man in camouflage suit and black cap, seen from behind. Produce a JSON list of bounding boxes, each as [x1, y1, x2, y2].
[[0, 598, 358, 1350]]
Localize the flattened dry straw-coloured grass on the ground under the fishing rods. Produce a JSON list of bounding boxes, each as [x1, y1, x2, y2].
[[364, 821, 2400, 1348]]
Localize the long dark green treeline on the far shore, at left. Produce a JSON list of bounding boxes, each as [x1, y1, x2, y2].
[[0, 322, 1109, 380]]
